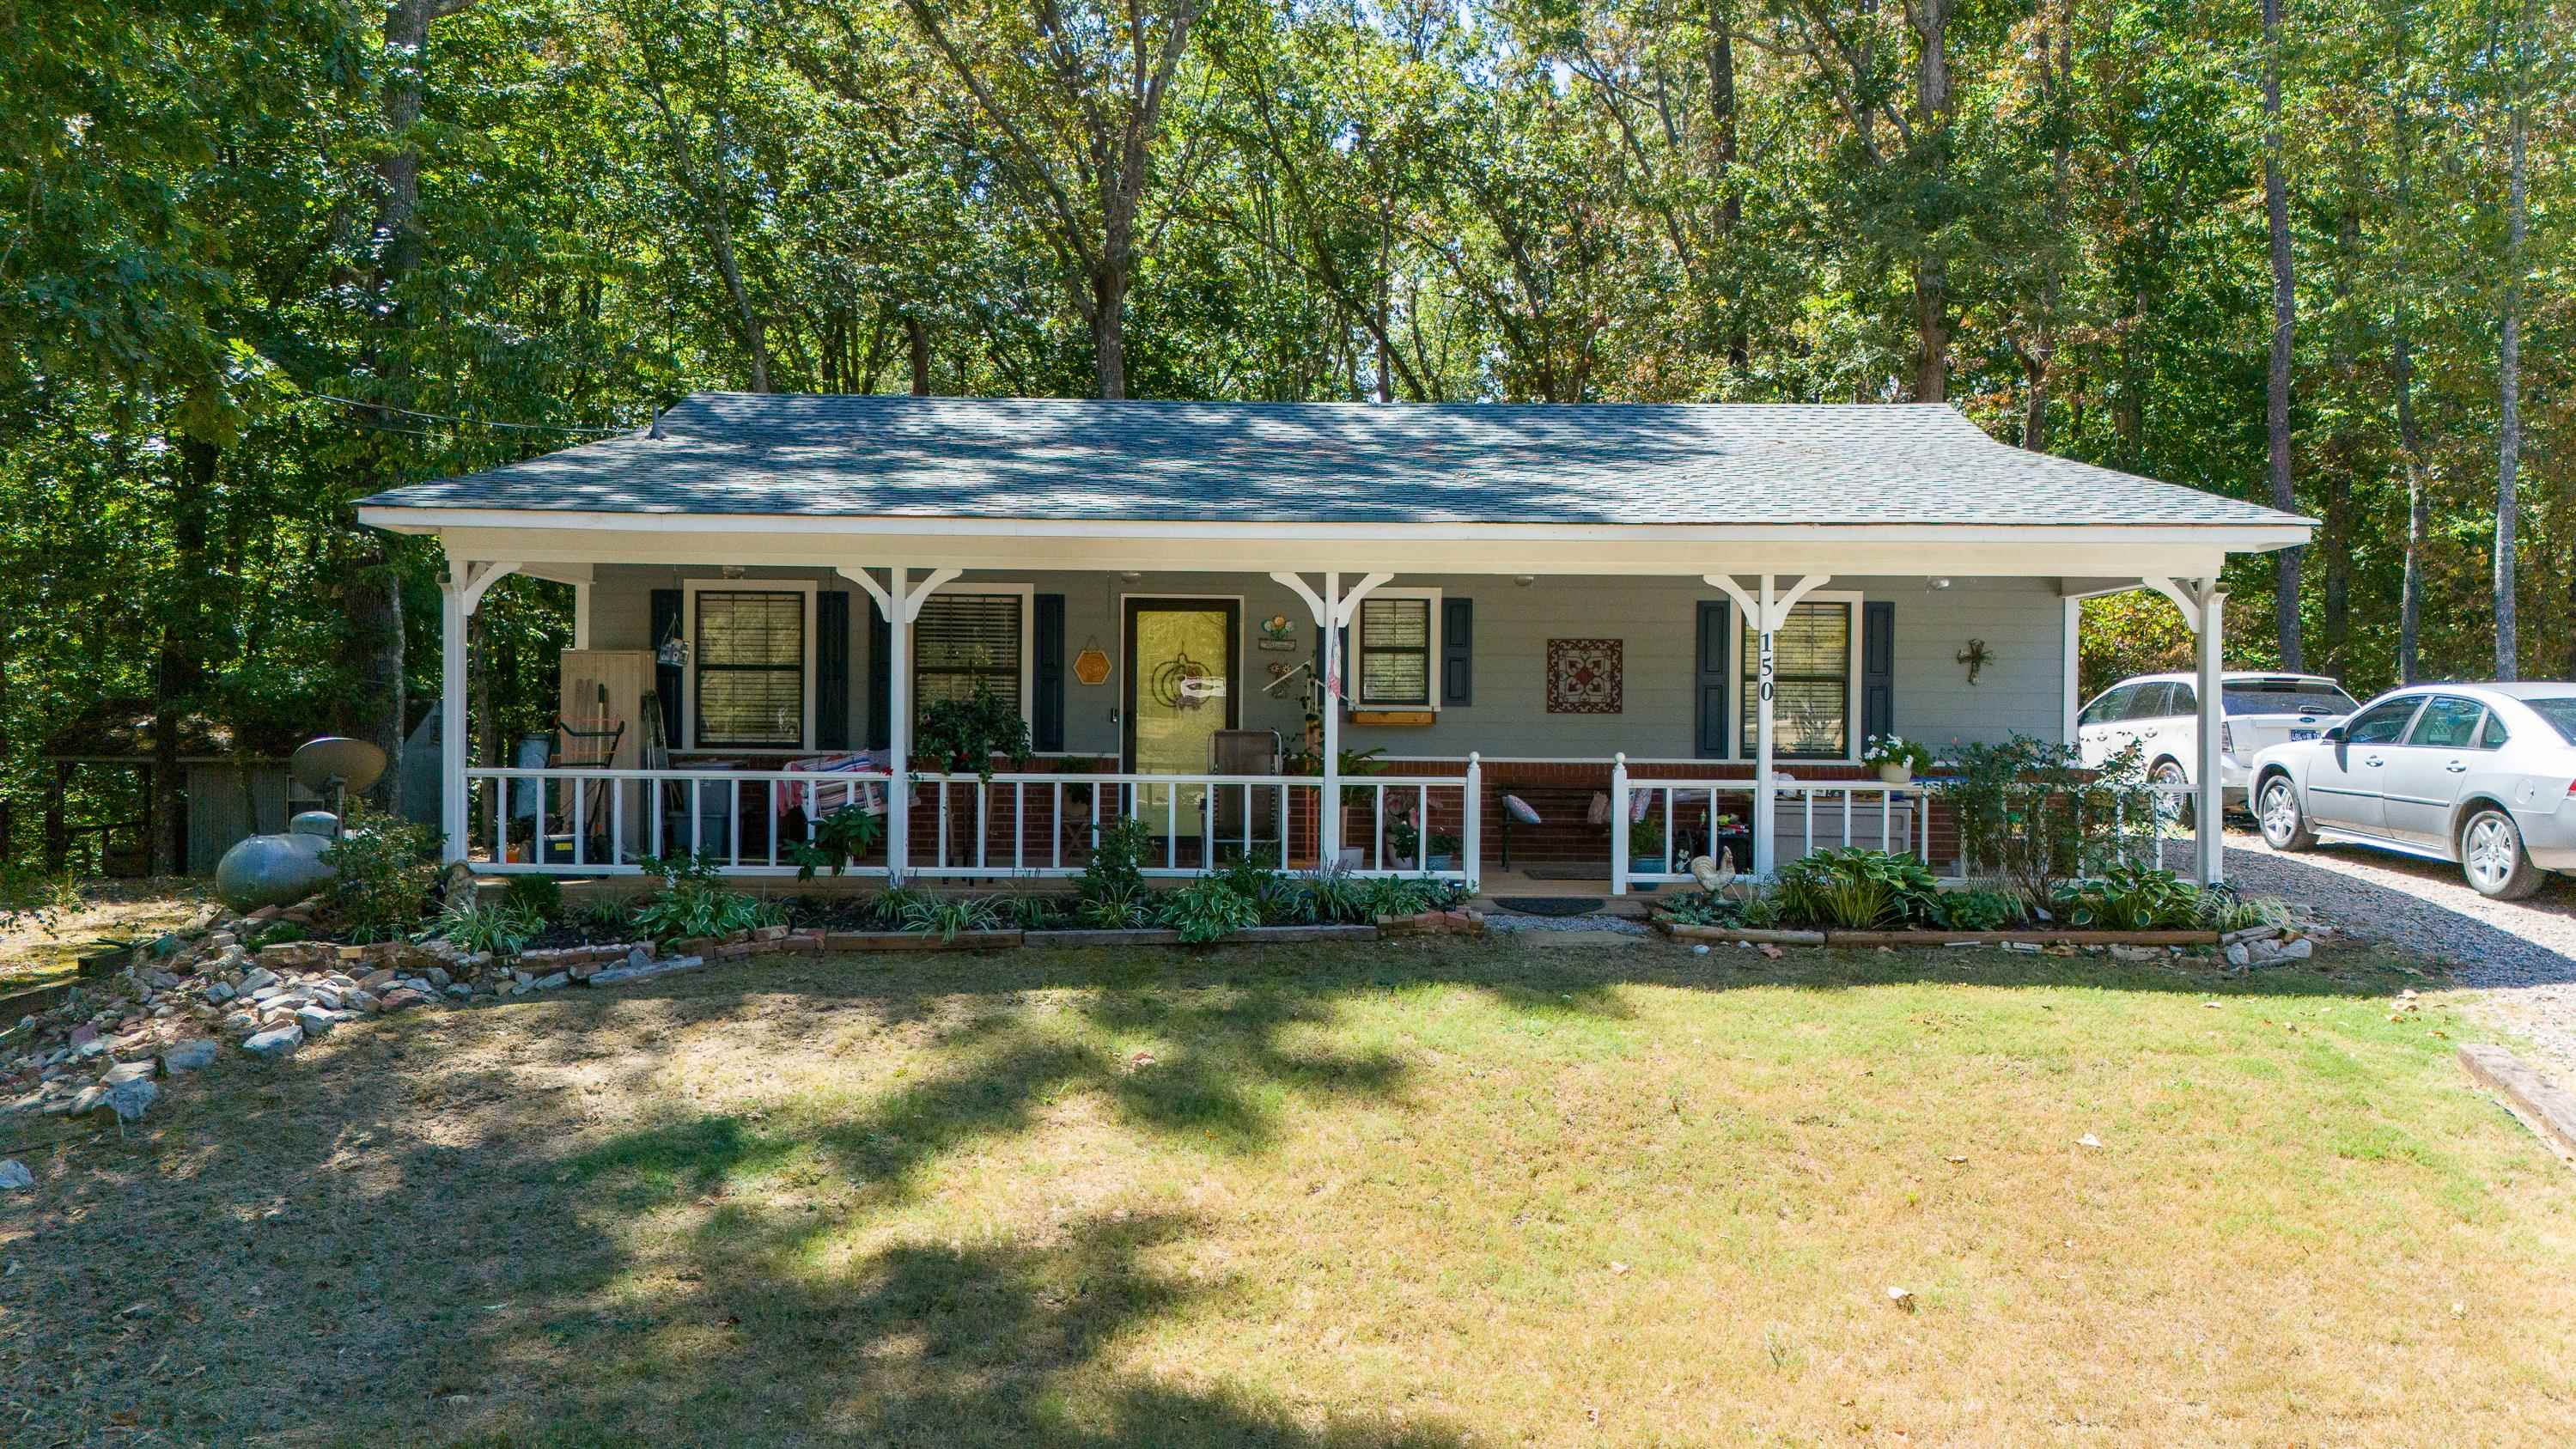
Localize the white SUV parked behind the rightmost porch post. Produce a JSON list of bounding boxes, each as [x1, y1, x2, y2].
[[2076, 672, 2354, 806]]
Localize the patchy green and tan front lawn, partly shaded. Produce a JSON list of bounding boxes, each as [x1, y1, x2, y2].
[[0, 942, 2576, 1446]]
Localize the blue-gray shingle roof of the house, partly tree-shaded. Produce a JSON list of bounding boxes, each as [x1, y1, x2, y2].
[[366, 393, 2295, 525]]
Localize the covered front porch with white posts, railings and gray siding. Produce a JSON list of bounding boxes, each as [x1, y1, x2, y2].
[[422, 558, 2220, 896]]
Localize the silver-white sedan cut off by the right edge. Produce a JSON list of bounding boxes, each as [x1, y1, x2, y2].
[[2254, 685, 2576, 901]]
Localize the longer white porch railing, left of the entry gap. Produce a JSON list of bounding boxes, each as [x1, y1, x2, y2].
[[466, 759, 1483, 888]]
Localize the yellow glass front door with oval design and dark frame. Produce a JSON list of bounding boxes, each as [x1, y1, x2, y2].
[[1126, 600, 1242, 839]]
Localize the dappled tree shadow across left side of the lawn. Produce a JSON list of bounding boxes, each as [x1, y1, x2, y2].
[[0, 940, 2432, 1446]]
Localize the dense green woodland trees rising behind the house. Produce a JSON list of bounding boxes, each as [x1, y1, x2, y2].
[[0, 0, 2576, 857]]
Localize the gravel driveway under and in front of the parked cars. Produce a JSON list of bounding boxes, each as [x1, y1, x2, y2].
[[2174, 831, 2576, 1084]]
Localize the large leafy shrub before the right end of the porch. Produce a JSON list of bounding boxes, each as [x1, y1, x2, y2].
[[1937, 734, 2156, 906]]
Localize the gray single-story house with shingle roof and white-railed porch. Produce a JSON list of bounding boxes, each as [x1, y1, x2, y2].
[[361, 393, 2313, 893]]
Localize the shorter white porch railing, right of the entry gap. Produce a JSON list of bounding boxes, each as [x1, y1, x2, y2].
[[1610, 762, 2195, 896]]
